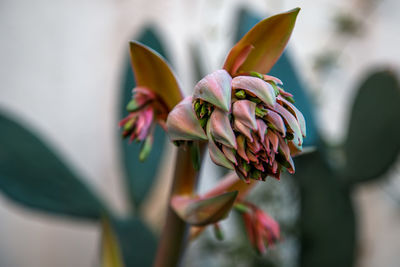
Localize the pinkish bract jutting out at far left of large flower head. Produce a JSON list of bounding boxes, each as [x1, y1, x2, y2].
[[167, 96, 207, 141]]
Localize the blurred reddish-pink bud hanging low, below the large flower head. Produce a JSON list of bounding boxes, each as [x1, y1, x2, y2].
[[236, 202, 280, 254]]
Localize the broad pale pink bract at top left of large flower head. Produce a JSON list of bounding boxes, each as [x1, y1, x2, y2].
[[193, 70, 232, 111]]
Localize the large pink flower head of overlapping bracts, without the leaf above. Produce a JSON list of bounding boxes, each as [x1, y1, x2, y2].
[[167, 70, 306, 182]]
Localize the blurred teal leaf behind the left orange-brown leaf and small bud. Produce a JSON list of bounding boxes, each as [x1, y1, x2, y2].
[[119, 27, 166, 211]]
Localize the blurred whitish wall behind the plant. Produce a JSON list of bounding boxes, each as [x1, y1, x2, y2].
[[0, 0, 400, 267]]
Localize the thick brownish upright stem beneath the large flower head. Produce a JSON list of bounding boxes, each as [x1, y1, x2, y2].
[[154, 144, 205, 267]]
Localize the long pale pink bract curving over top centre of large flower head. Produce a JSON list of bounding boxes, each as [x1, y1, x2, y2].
[[232, 76, 276, 107]]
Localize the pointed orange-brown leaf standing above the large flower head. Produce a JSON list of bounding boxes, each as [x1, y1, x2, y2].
[[224, 8, 300, 74]]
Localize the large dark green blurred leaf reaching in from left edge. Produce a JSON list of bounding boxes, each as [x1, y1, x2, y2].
[[0, 115, 105, 219]]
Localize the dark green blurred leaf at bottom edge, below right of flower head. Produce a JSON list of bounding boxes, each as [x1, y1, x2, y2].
[[293, 151, 356, 267]]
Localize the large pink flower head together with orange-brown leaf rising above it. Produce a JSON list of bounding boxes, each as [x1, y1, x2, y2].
[[167, 9, 306, 182]]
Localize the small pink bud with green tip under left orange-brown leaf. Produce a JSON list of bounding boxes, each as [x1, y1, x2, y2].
[[119, 87, 168, 161]]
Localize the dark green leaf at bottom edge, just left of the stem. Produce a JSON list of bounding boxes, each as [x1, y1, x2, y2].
[[112, 217, 157, 267]]
